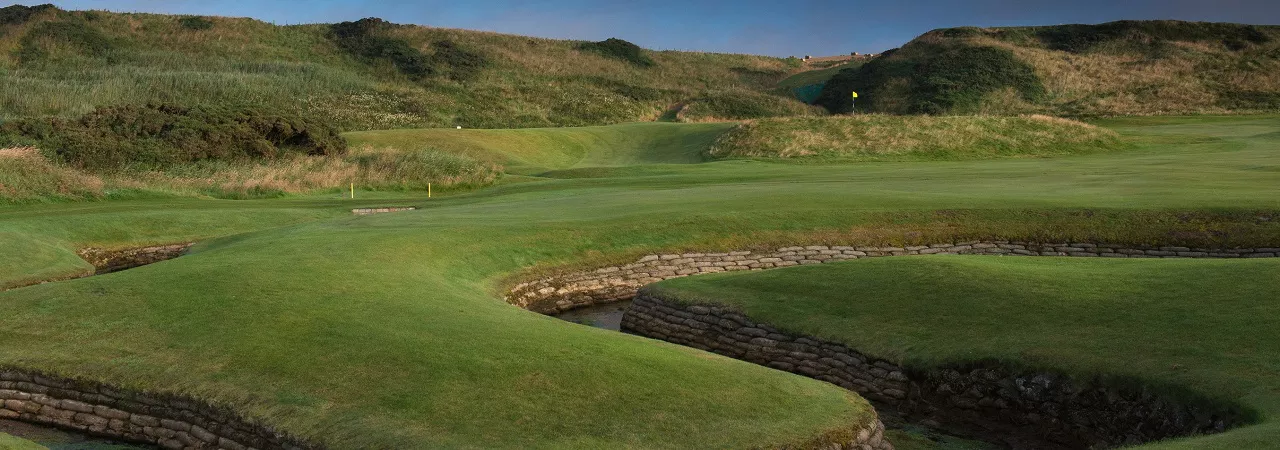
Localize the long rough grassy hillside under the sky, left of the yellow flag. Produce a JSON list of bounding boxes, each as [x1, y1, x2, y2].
[[0, 5, 813, 130]]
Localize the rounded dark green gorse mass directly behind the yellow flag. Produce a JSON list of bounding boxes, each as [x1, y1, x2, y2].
[[815, 42, 1046, 114]]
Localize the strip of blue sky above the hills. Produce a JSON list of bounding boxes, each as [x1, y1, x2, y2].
[[28, 0, 1280, 56]]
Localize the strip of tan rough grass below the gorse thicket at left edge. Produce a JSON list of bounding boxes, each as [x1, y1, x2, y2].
[[0, 144, 502, 203]]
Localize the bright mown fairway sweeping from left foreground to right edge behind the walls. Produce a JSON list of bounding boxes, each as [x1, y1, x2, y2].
[[0, 118, 1280, 447]]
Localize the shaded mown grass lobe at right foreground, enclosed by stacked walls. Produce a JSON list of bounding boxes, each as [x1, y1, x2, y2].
[[653, 257, 1280, 449]]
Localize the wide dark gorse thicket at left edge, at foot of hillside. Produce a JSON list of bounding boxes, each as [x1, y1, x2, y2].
[[0, 105, 347, 170]]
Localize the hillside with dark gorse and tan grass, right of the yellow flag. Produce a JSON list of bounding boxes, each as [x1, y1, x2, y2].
[[818, 20, 1280, 116]]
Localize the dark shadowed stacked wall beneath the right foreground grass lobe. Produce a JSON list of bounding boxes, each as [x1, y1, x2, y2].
[[622, 294, 1247, 449]]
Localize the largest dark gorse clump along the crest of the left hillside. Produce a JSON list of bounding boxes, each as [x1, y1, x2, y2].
[[330, 18, 489, 81]]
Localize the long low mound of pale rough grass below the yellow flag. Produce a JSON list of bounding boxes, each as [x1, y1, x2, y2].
[[709, 115, 1123, 161]]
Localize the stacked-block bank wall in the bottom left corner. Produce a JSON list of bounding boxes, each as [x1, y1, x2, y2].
[[0, 368, 321, 450]]
